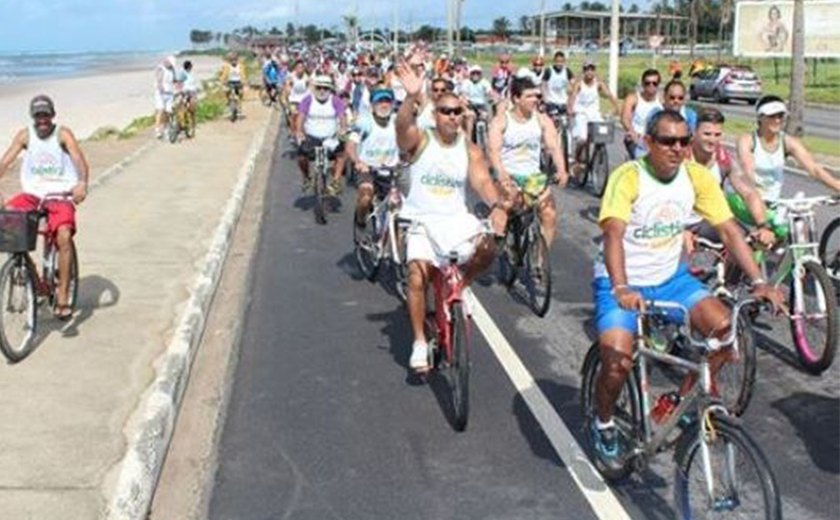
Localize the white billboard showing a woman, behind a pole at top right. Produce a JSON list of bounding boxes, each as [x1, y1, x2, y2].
[[733, 0, 840, 58]]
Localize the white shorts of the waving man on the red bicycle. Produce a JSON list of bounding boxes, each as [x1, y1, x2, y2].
[[405, 213, 481, 267]]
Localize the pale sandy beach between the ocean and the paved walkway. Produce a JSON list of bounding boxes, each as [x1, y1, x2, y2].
[[0, 56, 221, 143]]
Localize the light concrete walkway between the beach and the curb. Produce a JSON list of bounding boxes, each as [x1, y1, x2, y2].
[[0, 103, 268, 519]]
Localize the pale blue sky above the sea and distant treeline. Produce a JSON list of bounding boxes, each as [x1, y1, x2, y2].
[[0, 0, 647, 52]]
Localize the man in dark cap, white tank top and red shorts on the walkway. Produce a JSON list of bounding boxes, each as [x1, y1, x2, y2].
[[0, 95, 89, 320]]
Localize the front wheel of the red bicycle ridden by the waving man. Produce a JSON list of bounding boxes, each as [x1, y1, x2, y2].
[[447, 303, 470, 432]]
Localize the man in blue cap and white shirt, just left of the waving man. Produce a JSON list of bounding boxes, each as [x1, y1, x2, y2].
[[347, 89, 400, 227]]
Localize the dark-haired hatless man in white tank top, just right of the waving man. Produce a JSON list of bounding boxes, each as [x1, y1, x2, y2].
[[489, 76, 569, 248]]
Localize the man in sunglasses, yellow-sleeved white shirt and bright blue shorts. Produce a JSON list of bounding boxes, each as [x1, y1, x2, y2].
[[589, 110, 783, 469]]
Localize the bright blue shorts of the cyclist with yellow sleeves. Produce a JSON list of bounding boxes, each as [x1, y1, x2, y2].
[[592, 263, 711, 335]]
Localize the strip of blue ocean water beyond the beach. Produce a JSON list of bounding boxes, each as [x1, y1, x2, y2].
[[0, 52, 165, 84]]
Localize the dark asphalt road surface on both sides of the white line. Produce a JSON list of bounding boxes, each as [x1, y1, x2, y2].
[[210, 132, 840, 520]]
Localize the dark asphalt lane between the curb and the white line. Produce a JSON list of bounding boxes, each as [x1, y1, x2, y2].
[[209, 137, 594, 520]]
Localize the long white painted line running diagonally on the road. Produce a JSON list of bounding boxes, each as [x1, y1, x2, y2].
[[465, 289, 631, 520]]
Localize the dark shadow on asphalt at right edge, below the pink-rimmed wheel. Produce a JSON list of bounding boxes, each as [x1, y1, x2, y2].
[[771, 392, 840, 475]]
